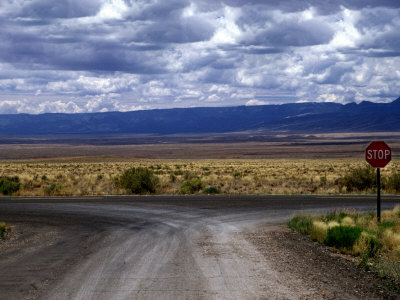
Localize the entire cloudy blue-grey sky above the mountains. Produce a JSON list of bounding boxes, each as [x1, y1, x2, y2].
[[0, 0, 400, 114]]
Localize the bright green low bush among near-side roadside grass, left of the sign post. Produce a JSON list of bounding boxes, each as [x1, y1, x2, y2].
[[324, 225, 362, 250]]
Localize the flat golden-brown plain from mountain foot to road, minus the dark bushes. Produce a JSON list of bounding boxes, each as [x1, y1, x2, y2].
[[0, 133, 400, 196]]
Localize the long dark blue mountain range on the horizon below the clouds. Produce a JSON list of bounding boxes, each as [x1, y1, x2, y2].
[[0, 98, 400, 136]]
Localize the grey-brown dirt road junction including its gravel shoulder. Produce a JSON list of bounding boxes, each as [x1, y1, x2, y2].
[[0, 196, 400, 300]]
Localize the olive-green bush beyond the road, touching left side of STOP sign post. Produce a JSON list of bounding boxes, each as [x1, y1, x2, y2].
[[341, 166, 376, 192]]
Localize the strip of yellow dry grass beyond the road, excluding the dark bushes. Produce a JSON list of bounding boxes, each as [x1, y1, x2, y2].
[[0, 159, 400, 196]]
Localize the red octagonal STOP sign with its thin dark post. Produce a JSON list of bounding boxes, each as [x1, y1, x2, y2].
[[365, 141, 392, 222]]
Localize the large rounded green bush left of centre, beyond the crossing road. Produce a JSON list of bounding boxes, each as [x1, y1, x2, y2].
[[116, 167, 159, 194]]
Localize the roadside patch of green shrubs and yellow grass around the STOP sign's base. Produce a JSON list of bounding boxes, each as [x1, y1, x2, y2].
[[288, 206, 400, 289]]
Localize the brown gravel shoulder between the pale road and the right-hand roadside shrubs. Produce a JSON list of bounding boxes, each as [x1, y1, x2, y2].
[[246, 225, 400, 299]]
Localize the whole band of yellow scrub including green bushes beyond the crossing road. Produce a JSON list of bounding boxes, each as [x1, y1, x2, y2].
[[0, 158, 400, 196]]
